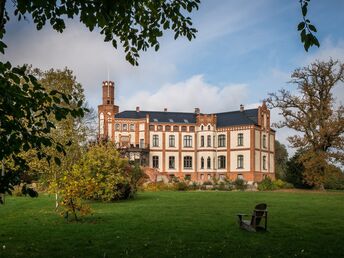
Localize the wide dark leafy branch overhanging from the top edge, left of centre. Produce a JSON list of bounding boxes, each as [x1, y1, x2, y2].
[[4, 0, 200, 65]]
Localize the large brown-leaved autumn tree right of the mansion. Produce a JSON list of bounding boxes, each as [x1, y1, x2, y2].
[[268, 59, 344, 188]]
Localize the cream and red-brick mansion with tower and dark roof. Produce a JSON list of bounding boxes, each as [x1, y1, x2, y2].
[[98, 81, 275, 183]]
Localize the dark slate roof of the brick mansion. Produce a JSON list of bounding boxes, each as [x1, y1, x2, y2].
[[115, 108, 258, 127]]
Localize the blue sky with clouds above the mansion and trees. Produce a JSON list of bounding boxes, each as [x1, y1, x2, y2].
[[1, 0, 344, 153]]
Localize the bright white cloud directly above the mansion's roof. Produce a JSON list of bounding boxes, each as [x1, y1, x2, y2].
[[118, 75, 248, 113]]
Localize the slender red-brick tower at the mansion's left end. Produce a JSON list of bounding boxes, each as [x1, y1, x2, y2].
[[98, 81, 119, 140]]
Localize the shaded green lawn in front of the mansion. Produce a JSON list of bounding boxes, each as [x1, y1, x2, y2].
[[0, 192, 344, 257]]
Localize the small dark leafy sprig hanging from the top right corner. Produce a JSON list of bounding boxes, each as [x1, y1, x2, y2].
[[297, 0, 320, 51]]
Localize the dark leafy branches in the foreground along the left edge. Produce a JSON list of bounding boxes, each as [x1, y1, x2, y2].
[[0, 62, 85, 197]]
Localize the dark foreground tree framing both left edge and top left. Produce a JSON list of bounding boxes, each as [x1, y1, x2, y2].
[[0, 0, 199, 203]]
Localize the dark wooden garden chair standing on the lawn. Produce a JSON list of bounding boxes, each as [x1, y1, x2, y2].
[[238, 203, 268, 232]]
